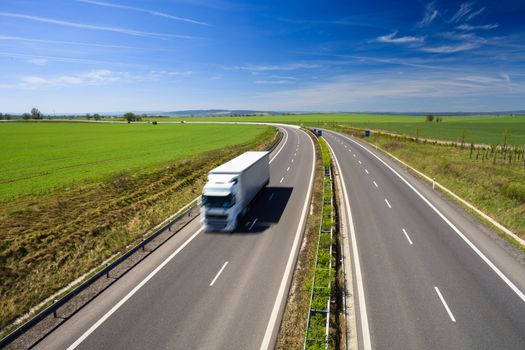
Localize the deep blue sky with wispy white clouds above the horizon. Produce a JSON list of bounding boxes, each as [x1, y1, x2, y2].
[[0, 0, 525, 113]]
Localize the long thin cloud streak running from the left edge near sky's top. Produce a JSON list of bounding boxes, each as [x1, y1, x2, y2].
[[0, 12, 194, 39]]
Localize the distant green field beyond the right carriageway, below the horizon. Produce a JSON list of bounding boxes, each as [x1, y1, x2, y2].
[[185, 114, 525, 144]]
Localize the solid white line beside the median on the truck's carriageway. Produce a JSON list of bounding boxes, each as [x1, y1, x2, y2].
[[261, 129, 315, 350]]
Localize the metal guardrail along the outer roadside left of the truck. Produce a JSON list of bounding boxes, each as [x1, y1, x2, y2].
[[0, 125, 283, 349]]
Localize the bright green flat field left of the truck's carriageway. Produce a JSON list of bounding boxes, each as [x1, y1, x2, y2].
[[0, 122, 267, 202]]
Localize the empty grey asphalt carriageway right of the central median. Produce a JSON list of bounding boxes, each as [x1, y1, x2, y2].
[[325, 131, 525, 350]]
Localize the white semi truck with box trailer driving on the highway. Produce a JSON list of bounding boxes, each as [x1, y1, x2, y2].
[[201, 152, 270, 232]]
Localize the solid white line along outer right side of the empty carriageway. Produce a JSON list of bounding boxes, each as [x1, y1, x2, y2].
[[334, 131, 525, 302]]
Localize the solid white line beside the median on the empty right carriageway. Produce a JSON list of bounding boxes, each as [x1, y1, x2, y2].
[[326, 138, 372, 350]]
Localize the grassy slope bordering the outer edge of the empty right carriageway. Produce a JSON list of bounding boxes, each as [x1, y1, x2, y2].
[[338, 127, 525, 242]]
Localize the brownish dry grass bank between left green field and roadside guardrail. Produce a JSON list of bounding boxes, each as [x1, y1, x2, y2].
[[0, 126, 275, 328]]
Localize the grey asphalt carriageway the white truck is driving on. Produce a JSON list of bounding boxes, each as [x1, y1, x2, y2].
[[36, 127, 315, 349]]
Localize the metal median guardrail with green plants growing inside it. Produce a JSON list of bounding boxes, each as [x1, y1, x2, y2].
[[303, 167, 334, 349]]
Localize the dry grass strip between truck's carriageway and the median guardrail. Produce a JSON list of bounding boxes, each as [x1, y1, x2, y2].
[[275, 134, 323, 350]]
